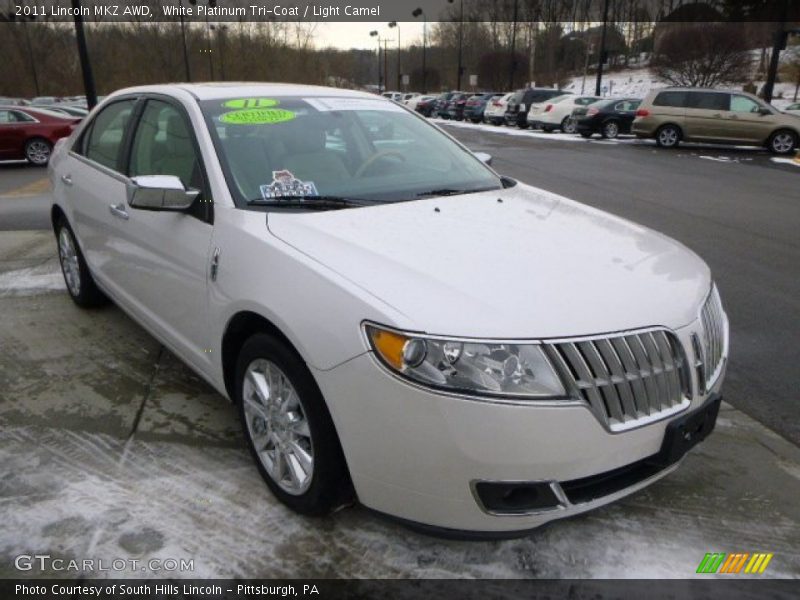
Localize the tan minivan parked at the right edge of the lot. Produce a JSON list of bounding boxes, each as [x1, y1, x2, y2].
[[633, 88, 800, 154]]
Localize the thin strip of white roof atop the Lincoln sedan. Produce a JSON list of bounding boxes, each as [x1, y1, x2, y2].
[[112, 82, 381, 101]]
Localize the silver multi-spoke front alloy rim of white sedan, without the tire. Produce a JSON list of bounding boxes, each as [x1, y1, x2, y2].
[[242, 359, 314, 496]]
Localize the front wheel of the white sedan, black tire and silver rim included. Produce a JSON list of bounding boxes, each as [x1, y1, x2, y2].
[[236, 333, 354, 515]]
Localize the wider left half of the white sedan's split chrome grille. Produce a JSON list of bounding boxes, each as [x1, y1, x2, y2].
[[545, 329, 691, 430]]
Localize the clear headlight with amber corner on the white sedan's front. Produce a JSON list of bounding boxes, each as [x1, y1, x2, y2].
[[364, 324, 567, 399]]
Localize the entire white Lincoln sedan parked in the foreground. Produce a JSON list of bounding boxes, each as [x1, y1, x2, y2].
[[50, 84, 728, 535]]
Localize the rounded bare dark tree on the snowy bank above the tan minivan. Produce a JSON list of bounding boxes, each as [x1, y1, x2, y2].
[[650, 22, 752, 87]]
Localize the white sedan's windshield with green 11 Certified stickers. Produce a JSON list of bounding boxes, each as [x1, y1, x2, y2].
[[200, 96, 502, 206]]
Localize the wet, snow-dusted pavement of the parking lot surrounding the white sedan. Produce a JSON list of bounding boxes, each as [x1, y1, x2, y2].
[[0, 123, 800, 578]]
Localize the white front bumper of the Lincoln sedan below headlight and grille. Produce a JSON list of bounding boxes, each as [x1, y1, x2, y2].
[[314, 324, 723, 535]]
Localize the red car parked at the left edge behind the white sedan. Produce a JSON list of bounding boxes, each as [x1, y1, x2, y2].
[[0, 106, 81, 166]]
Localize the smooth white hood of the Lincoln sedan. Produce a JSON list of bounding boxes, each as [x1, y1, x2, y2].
[[267, 184, 711, 338]]
